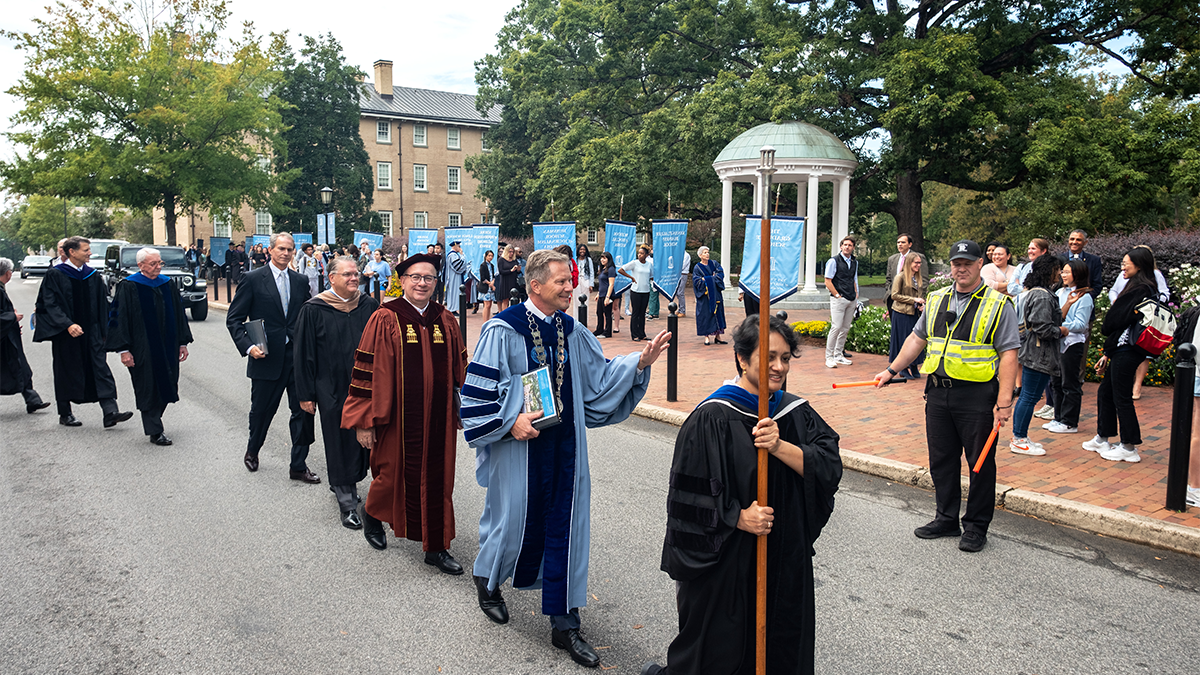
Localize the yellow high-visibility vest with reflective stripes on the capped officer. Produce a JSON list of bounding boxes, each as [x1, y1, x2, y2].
[[920, 283, 1008, 382]]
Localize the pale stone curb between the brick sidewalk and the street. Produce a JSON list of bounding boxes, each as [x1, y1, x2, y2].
[[634, 404, 1200, 556]]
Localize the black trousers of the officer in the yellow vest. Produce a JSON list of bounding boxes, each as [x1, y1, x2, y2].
[[925, 378, 1000, 534]]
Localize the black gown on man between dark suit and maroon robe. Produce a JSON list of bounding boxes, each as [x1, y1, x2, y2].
[[293, 294, 379, 485]]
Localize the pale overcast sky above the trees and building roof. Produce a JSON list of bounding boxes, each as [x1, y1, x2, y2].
[[0, 0, 518, 201]]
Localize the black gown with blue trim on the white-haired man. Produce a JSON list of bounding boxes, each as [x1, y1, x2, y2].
[[106, 273, 192, 411]]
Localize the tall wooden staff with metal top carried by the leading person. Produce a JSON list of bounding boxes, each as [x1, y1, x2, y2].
[[755, 145, 775, 675]]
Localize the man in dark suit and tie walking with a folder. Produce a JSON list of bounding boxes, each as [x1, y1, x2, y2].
[[226, 233, 320, 483]]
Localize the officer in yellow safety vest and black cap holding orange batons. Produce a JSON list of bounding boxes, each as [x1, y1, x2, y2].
[[875, 240, 1021, 552]]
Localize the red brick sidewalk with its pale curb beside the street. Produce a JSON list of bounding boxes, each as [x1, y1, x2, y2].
[[210, 294, 1200, 555]]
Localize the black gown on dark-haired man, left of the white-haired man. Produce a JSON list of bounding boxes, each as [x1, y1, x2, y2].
[[34, 263, 116, 404]]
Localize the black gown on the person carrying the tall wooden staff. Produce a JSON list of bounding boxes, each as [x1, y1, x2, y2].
[[662, 386, 841, 675]]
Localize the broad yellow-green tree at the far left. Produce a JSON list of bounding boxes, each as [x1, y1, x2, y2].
[[0, 0, 292, 244]]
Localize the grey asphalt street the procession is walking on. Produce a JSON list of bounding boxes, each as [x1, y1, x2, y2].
[[0, 279, 1200, 675]]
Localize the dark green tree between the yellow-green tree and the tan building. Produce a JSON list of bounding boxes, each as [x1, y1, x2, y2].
[[275, 35, 378, 240]]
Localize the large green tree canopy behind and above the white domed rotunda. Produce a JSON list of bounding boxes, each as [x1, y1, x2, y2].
[[476, 0, 1200, 250]]
